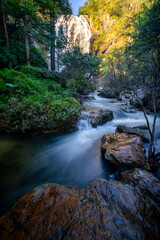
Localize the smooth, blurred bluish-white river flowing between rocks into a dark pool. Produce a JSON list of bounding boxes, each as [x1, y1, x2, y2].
[[0, 92, 160, 214]]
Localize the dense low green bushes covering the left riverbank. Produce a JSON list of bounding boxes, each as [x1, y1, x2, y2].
[[0, 66, 79, 133]]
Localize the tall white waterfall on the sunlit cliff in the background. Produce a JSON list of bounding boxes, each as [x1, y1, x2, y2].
[[56, 15, 92, 71]]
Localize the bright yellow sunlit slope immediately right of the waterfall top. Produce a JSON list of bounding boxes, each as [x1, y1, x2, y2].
[[79, 0, 153, 55]]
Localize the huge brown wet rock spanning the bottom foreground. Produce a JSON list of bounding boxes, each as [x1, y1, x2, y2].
[[0, 170, 160, 240]]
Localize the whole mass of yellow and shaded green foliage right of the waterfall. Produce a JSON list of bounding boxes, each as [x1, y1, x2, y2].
[[79, 0, 160, 88]]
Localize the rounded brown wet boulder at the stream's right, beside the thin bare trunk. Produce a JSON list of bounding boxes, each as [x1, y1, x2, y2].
[[101, 133, 146, 167]]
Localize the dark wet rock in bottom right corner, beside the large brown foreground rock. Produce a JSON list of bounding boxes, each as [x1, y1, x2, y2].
[[120, 169, 160, 239]]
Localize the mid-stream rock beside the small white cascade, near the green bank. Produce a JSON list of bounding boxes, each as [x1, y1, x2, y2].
[[82, 110, 113, 127]]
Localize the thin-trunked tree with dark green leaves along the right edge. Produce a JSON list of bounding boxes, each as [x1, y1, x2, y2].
[[126, 0, 160, 167]]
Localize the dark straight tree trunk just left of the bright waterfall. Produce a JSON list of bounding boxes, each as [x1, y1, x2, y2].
[[51, 13, 56, 71]]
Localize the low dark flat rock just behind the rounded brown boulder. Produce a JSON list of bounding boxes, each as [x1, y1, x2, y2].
[[116, 125, 149, 143]]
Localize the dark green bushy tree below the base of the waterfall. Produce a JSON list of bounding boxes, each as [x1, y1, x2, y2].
[[61, 47, 101, 94]]
